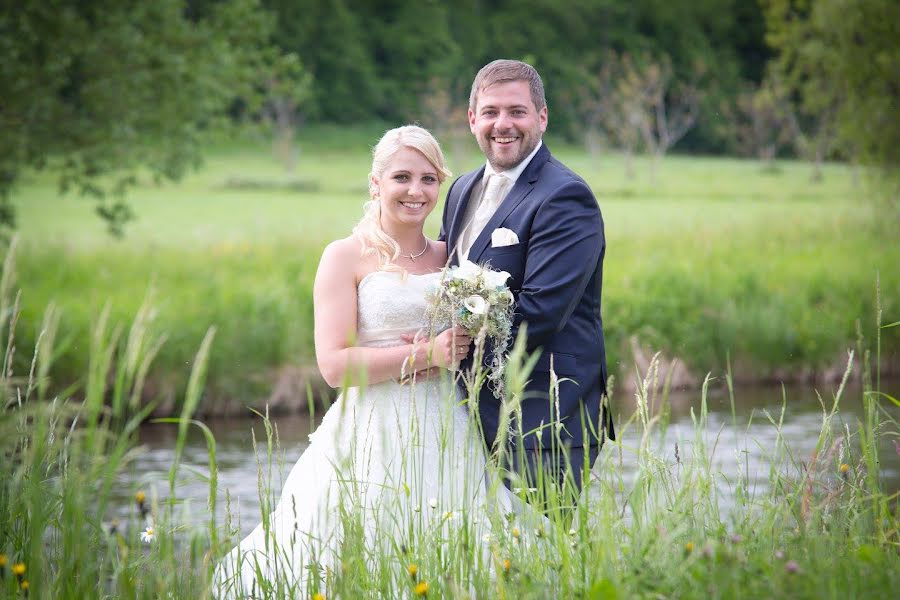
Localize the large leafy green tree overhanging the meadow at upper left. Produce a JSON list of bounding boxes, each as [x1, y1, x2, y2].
[[0, 0, 271, 238]]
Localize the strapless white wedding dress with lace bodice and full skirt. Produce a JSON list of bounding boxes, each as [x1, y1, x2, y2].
[[213, 271, 516, 598]]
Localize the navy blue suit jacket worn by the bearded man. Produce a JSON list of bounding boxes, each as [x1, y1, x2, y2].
[[440, 145, 614, 449]]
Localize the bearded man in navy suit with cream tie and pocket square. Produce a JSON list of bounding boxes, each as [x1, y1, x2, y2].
[[440, 60, 614, 491]]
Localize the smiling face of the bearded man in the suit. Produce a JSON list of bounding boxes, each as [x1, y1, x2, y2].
[[469, 81, 547, 171]]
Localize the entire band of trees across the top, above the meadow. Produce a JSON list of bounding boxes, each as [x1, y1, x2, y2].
[[0, 0, 900, 237]]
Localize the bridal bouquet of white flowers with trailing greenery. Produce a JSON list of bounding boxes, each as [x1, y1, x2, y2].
[[427, 260, 514, 398]]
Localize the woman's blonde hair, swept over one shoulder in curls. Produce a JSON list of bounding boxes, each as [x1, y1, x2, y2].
[[353, 125, 452, 271]]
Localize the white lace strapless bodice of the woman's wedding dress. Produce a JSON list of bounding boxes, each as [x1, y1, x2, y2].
[[357, 271, 440, 346]]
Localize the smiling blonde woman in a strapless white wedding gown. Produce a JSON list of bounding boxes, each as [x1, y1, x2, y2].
[[214, 126, 513, 598]]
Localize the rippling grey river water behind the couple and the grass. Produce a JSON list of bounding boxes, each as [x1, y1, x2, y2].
[[120, 382, 900, 533]]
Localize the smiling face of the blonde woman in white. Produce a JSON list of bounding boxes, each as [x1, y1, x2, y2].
[[372, 146, 441, 234]]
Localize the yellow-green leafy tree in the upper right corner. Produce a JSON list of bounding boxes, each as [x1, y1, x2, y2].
[[763, 0, 900, 194]]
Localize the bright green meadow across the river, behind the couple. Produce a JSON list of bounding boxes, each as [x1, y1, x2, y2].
[[8, 126, 900, 409]]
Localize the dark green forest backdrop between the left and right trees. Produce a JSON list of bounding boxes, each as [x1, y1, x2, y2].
[[264, 0, 772, 153]]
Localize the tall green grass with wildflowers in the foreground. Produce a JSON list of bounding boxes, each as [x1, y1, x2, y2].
[[0, 241, 900, 599]]
